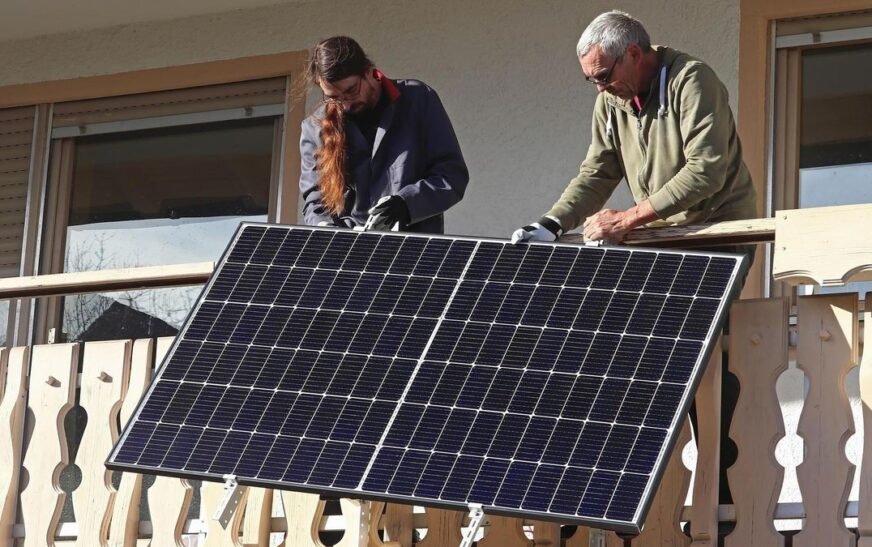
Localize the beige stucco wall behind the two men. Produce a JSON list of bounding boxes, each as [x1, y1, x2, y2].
[[0, 0, 739, 237]]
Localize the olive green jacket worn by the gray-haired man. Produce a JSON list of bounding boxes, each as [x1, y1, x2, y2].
[[546, 46, 757, 231]]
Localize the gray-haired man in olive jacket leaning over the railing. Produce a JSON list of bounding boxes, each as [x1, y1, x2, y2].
[[512, 11, 757, 245]]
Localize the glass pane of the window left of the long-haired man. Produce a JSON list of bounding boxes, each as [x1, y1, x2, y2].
[[62, 118, 274, 341]]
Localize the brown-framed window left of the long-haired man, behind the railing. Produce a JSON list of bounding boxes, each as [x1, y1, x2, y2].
[[10, 77, 301, 343]]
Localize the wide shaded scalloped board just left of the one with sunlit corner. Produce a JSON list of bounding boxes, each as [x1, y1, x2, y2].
[[725, 298, 789, 547]]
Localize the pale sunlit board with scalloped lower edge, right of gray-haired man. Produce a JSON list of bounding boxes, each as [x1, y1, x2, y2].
[[772, 203, 872, 287]]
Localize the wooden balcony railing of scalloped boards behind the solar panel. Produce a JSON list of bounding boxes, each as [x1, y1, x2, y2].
[[0, 207, 872, 547]]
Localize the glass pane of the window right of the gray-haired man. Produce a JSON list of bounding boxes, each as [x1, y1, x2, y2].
[[799, 44, 872, 298]]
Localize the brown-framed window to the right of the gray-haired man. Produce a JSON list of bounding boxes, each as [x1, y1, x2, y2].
[[772, 15, 872, 298]]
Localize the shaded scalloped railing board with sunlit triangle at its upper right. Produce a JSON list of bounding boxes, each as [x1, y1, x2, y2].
[[793, 293, 858, 547]]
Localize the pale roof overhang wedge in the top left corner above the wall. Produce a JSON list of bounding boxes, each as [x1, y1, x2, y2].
[[0, 0, 311, 42]]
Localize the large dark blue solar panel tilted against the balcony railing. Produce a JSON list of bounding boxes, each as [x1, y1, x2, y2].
[[107, 224, 745, 533]]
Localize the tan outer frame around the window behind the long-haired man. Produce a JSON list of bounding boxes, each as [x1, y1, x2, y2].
[[0, 51, 307, 346]]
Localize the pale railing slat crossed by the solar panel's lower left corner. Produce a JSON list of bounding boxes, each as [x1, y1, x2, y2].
[[109, 338, 154, 547]]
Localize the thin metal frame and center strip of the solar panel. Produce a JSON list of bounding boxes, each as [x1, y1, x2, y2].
[[105, 222, 747, 535]]
